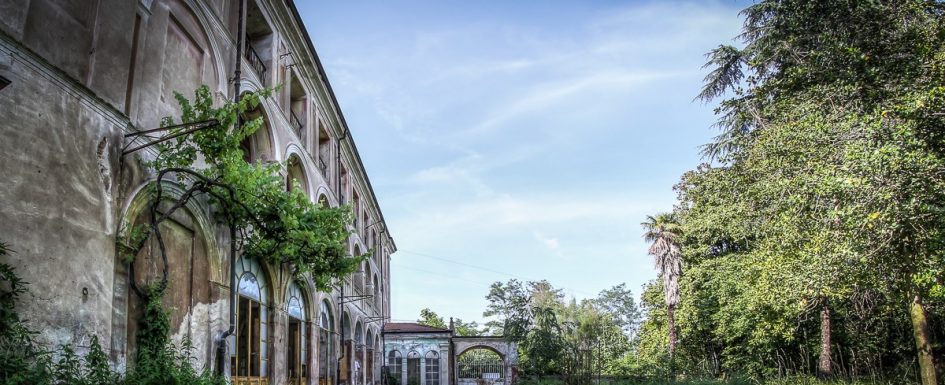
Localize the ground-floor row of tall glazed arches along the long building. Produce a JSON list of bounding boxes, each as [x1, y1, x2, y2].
[[228, 258, 381, 385]]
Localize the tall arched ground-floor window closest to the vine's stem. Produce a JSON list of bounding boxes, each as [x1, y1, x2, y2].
[[230, 258, 269, 384]]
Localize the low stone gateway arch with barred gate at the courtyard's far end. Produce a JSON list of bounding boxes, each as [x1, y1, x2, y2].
[[453, 337, 518, 385]]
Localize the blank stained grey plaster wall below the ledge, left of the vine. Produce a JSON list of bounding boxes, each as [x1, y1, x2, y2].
[[0, 36, 126, 347]]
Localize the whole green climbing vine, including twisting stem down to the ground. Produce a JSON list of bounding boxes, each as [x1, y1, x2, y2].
[[110, 86, 366, 378]]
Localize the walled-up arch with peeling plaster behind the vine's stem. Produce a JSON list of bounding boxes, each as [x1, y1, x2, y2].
[[112, 183, 227, 366]]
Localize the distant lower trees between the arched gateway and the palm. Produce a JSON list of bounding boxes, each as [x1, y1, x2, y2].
[[483, 279, 640, 384]]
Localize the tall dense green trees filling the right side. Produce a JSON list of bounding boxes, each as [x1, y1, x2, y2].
[[641, 0, 945, 384]]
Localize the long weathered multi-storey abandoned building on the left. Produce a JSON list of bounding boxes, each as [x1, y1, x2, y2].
[[0, 0, 396, 385]]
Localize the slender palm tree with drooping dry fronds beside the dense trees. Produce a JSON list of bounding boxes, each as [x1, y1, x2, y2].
[[640, 213, 682, 359]]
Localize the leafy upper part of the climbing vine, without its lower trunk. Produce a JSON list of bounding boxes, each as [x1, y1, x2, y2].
[[119, 86, 366, 294]]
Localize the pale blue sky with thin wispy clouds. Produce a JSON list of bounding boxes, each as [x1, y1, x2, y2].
[[297, 0, 746, 322]]
